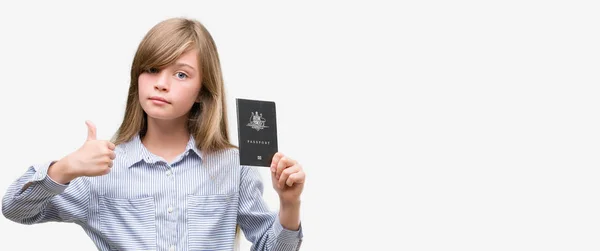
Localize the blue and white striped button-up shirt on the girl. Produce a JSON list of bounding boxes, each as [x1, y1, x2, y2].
[[2, 136, 302, 251]]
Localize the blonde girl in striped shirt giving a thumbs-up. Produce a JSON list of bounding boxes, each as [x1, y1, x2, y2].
[[2, 18, 305, 250]]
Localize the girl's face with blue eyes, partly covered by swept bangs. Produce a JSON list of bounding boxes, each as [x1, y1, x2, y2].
[[138, 50, 202, 120]]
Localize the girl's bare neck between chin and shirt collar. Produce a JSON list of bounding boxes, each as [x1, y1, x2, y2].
[[142, 116, 190, 160]]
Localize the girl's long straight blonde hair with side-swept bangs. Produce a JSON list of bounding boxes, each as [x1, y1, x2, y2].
[[112, 18, 241, 250]]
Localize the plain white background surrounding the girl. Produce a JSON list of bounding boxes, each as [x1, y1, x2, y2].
[[0, 1, 600, 251]]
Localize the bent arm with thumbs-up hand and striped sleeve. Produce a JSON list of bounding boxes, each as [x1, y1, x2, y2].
[[2, 121, 116, 224]]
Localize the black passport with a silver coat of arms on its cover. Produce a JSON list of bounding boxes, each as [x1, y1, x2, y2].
[[236, 98, 277, 167]]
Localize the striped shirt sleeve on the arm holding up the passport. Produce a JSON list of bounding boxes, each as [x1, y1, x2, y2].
[[238, 166, 303, 251]]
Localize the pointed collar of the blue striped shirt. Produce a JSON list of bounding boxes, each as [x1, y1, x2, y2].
[[122, 134, 202, 168]]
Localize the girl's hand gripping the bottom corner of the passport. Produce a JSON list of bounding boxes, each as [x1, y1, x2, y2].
[[271, 152, 306, 203]]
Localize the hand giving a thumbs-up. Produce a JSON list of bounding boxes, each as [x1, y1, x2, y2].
[[48, 121, 116, 184]]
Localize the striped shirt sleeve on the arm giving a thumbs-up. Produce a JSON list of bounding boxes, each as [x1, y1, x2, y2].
[[2, 162, 89, 225]]
